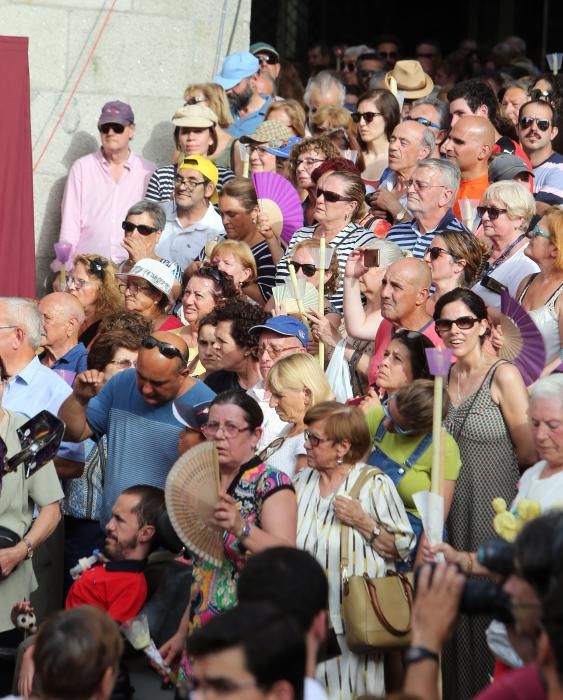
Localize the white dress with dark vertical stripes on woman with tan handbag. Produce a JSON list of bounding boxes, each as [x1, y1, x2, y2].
[[294, 463, 415, 700]]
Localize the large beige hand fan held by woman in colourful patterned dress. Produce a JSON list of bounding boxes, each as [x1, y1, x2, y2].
[[164, 442, 224, 567]]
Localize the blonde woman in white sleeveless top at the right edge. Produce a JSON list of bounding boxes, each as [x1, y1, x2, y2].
[[516, 207, 563, 376]]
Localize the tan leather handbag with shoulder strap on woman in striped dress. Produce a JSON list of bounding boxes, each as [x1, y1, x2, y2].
[[340, 468, 413, 653]]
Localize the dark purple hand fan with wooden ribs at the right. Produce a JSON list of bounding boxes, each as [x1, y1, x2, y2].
[[499, 292, 546, 386]]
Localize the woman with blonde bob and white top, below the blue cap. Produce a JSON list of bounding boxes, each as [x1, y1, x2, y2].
[[260, 352, 332, 477]]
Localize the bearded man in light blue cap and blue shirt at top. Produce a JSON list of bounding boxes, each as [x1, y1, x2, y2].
[[213, 51, 272, 139]]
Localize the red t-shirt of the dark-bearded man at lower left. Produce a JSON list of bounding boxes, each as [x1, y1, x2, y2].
[[65, 560, 147, 623]]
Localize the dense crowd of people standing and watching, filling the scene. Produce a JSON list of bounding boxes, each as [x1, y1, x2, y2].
[[0, 30, 563, 700]]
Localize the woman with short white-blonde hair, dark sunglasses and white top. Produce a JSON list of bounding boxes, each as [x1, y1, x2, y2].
[[473, 180, 540, 307]]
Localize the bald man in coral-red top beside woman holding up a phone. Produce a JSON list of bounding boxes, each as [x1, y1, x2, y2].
[[368, 258, 440, 385]]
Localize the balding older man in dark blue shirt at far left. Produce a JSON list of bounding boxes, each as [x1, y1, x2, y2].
[[37, 292, 88, 374]]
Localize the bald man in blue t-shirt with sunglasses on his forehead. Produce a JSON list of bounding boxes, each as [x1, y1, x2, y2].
[[59, 331, 215, 528]]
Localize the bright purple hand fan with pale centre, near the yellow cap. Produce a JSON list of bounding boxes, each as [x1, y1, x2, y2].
[[252, 173, 303, 243]]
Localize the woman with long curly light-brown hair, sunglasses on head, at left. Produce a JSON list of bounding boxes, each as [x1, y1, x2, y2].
[[66, 253, 123, 346]]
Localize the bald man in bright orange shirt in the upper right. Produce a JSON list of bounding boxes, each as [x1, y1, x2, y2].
[[444, 116, 495, 217]]
